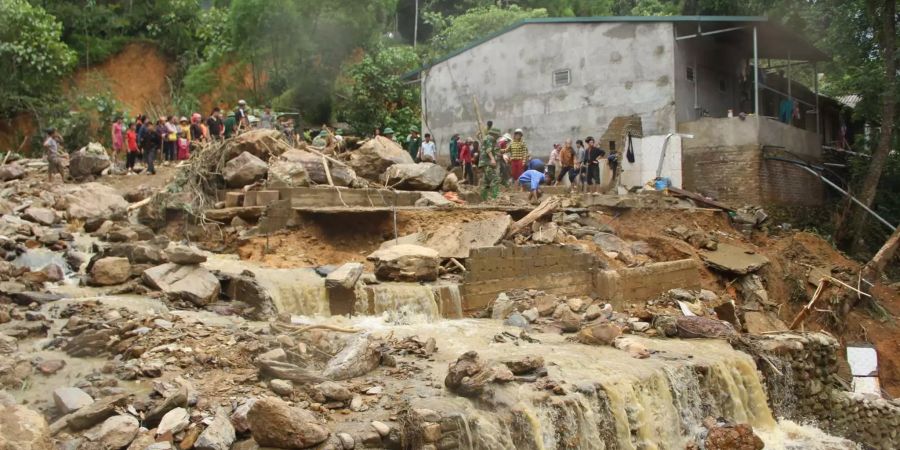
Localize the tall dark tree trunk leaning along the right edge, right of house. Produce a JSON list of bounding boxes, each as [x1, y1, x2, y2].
[[835, 0, 897, 253]]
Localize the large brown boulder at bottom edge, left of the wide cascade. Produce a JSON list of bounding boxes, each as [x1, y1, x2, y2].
[[247, 397, 330, 448]]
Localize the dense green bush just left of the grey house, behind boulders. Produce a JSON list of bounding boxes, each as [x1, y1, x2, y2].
[[338, 46, 420, 133]]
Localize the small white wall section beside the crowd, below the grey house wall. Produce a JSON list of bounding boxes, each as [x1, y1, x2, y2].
[[619, 135, 682, 188]]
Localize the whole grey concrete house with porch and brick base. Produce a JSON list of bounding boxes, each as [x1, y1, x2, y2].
[[409, 16, 840, 204]]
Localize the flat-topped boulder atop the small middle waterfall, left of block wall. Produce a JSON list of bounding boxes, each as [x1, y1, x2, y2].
[[368, 244, 440, 281]]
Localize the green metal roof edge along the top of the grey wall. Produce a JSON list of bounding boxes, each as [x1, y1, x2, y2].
[[400, 16, 769, 79]]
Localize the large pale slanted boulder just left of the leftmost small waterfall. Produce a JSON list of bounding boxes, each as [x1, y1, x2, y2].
[[142, 263, 221, 306]]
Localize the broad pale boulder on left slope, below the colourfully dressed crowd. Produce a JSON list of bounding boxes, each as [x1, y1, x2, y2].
[[54, 183, 128, 220]]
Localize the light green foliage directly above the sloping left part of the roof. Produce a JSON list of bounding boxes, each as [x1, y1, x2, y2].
[[424, 5, 547, 58]]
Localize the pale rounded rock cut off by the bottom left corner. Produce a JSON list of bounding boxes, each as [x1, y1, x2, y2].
[[0, 404, 55, 450]]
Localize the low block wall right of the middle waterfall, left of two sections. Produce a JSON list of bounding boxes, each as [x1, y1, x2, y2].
[[462, 245, 595, 312]]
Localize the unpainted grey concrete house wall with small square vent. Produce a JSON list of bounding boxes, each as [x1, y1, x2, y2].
[[422, 23, 675, 157]]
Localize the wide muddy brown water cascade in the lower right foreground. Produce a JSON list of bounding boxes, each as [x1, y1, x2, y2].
[[302, 317, 857, 450]]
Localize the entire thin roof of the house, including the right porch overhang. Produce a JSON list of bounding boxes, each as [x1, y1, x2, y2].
[[403, 16, 828, 78]]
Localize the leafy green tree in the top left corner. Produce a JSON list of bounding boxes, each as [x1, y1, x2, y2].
[[0, 0, 75, 116]]
